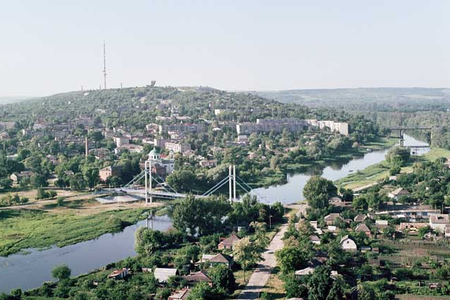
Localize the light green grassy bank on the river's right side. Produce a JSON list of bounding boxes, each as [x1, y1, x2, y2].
[[335, 148, 450, 189]]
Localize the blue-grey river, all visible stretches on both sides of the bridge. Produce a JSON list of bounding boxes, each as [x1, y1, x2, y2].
[[0, 136, 426, 292]]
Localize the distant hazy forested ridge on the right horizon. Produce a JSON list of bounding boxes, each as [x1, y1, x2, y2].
[[255, 88, 450, 112]]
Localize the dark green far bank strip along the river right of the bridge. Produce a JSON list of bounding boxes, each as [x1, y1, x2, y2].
[[244, 137, 398, 188]]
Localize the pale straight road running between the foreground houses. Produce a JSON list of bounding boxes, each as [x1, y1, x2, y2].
[[238, 204, 306, 300]]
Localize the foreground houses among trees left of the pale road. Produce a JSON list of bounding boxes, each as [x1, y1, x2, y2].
[[108, 233, 240, 300]]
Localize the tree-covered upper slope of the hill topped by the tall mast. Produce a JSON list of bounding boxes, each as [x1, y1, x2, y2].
[[0, 86, 376, 132]]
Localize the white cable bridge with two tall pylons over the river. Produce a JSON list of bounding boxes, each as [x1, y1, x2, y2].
[[110, 160, 264, 205]]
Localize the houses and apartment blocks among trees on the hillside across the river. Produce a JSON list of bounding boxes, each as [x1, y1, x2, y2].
[[0, 100, 348, 192]]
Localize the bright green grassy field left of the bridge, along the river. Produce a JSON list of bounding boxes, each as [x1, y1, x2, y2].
[[0, 207, 148, 256]]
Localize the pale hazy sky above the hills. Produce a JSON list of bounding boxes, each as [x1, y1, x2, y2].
[[0, 0, 450, 96]]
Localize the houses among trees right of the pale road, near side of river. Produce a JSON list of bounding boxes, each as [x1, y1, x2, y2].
[[295, 183, 450, 278]]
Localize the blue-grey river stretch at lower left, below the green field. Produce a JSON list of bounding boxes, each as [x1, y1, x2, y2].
[[0, 217, 172, 292]]
